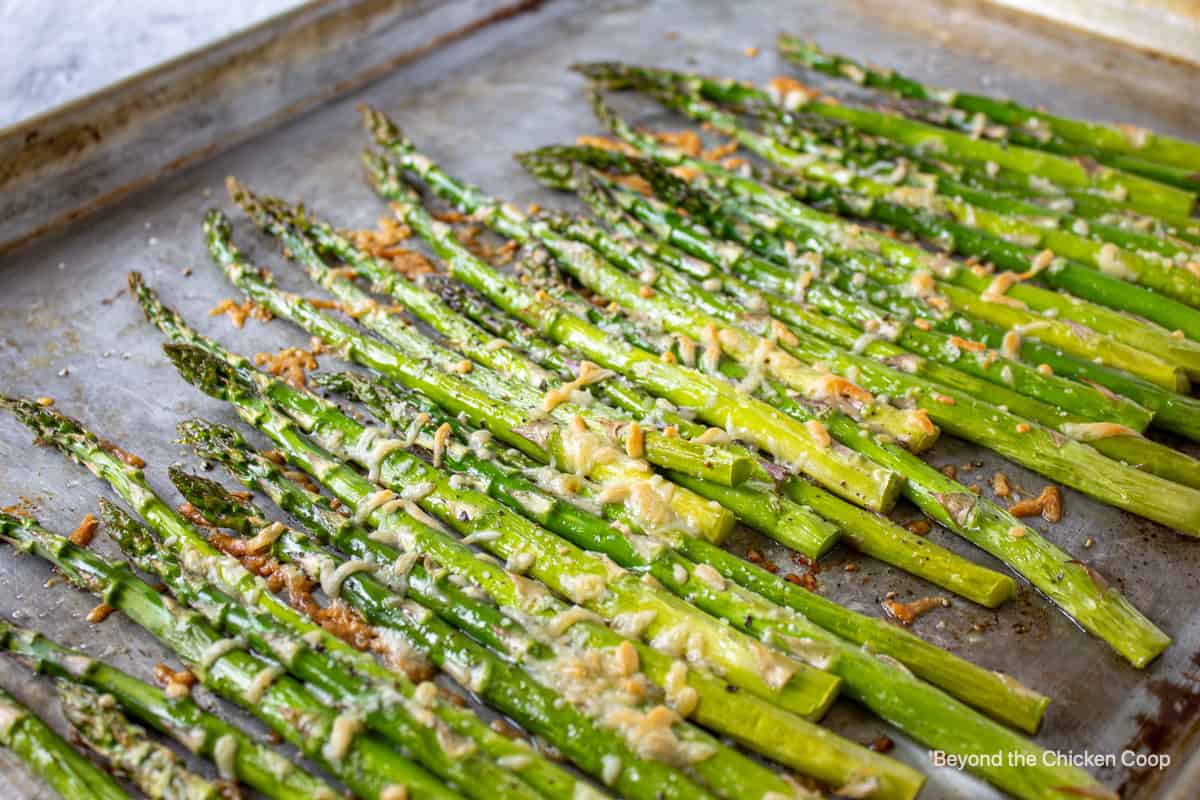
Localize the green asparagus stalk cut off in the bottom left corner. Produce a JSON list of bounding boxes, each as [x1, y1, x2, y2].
[[0, 681, 130, 800]]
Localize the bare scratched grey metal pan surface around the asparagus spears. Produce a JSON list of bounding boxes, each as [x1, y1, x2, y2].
[[0, 0, 1200, 800]]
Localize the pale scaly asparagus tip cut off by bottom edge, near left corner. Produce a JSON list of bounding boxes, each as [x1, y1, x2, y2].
[[55, 680, 222, 800]]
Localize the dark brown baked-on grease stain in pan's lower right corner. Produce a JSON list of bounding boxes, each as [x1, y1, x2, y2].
[[1118, 652, 1200, 798]]
